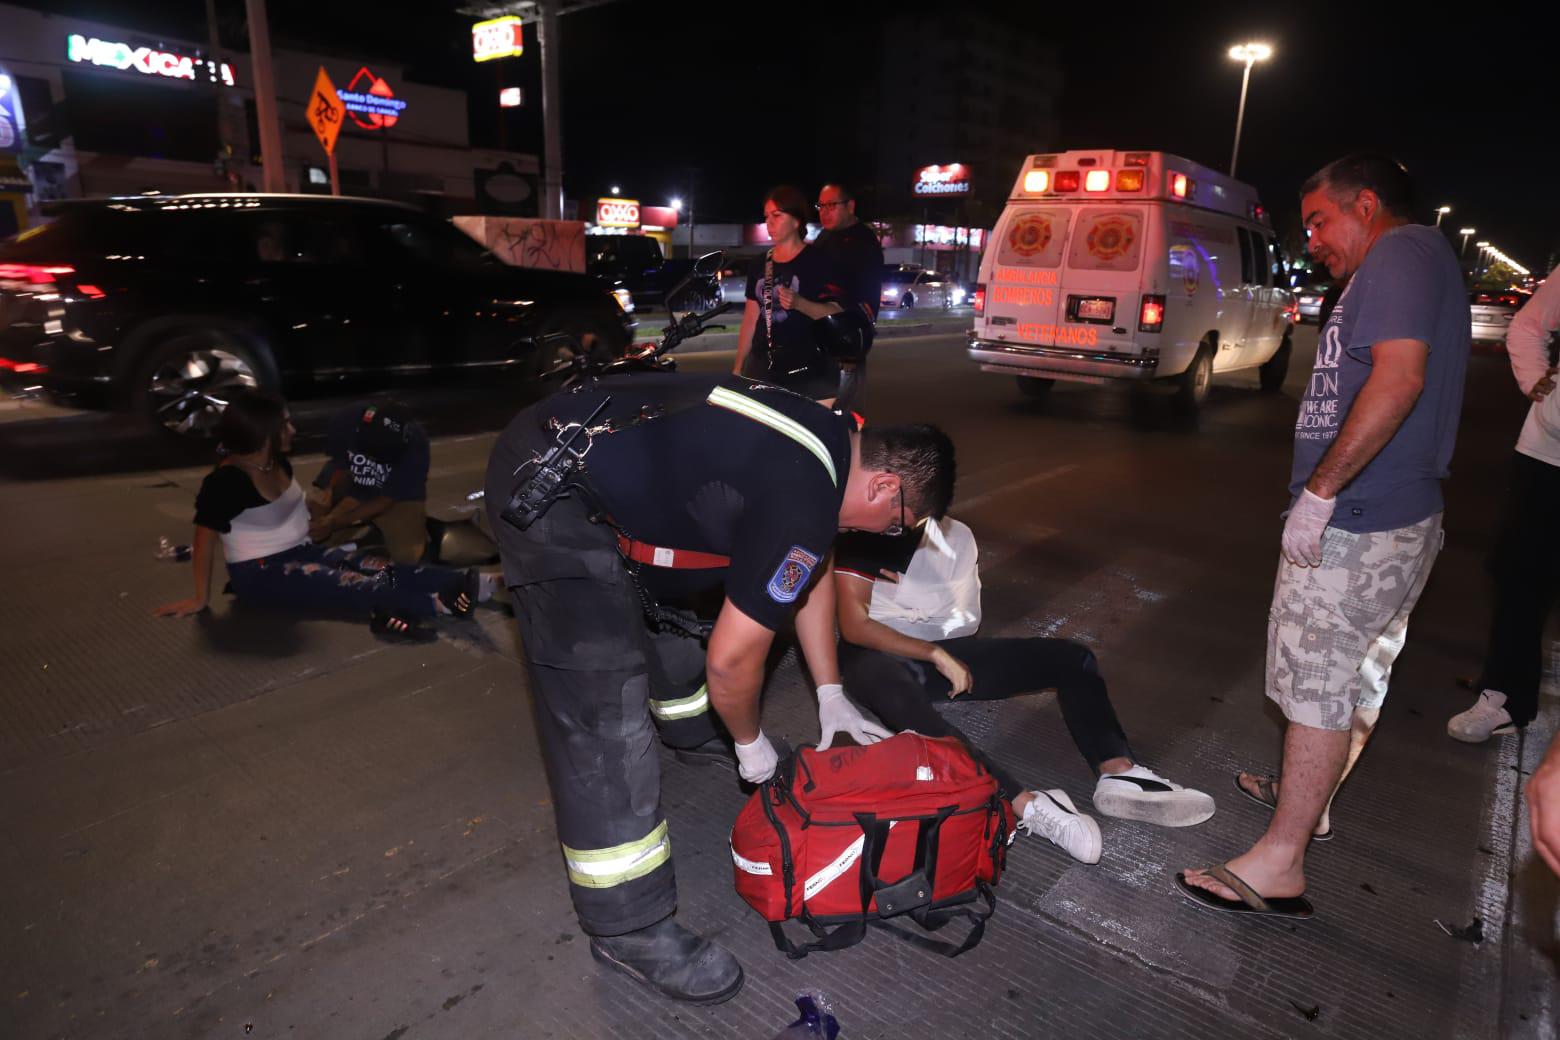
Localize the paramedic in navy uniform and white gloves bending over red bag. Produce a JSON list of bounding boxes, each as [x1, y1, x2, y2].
[[487, 374, 953, 1004]]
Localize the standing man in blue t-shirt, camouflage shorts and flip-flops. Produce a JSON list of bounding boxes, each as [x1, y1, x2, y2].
[[1176, 154, 1470, 917]]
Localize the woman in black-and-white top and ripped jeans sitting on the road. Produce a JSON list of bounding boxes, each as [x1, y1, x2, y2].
[[156, 391, 477, 639]]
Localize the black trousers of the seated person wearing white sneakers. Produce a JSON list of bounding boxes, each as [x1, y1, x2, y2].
[[839, 636, 1136, 800]]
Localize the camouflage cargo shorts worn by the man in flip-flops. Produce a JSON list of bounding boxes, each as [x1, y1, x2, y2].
[[1267, 513, 1445, 730]]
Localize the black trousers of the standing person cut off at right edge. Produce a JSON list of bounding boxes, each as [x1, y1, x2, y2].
[[1482, 452, 1560, 727]]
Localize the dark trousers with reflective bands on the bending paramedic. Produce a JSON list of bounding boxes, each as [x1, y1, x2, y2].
[[487, 486, 716, 936]]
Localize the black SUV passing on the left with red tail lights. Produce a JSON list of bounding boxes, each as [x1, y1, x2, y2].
[[0, 193, 633, 433]]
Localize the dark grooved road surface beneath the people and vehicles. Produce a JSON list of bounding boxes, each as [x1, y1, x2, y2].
[[0, 329, 1555, 1040]]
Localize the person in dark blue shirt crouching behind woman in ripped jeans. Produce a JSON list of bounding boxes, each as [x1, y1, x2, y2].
[[309, 402, 429, 564]]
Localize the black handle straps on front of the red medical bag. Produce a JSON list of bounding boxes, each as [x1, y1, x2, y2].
[[769, 806, 997, 960]]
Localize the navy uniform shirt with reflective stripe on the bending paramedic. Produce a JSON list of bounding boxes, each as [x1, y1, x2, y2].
[[495, 376, 855, 630]]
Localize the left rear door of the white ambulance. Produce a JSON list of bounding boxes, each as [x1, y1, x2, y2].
[[983, 203, 1076, 346]]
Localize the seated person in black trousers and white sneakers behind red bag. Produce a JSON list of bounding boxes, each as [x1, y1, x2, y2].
[[835, 516, 1214, 864]]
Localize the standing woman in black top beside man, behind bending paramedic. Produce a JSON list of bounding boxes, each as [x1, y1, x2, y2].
[[732, 184, 842, 404]]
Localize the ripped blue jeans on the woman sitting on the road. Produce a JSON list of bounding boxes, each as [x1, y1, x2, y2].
[[228, 544, 465, 617]]
